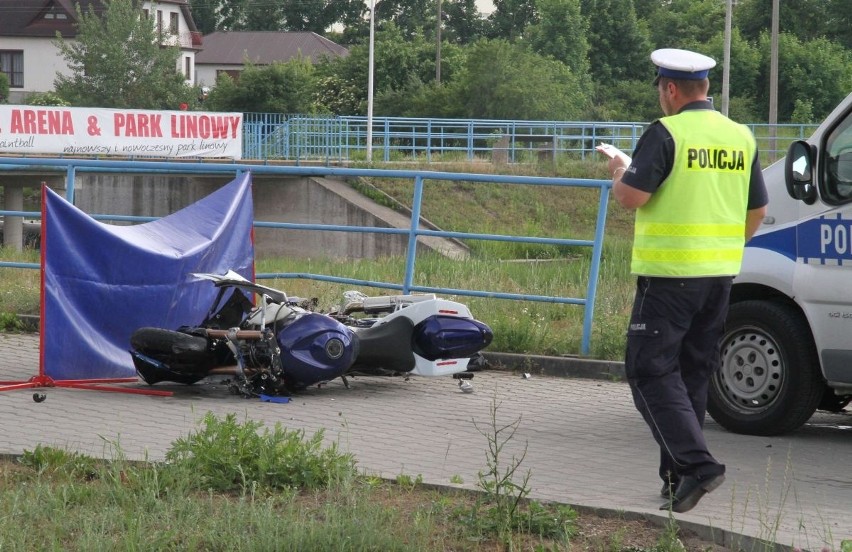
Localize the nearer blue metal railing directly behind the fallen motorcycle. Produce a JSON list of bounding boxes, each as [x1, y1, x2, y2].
[[0, 158, 611, 355]]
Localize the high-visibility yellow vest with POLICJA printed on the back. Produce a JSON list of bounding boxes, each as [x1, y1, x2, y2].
[[631, 110, 757, 277]]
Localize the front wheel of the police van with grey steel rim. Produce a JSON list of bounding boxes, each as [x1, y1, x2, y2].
[[707, 301, 825, 435]]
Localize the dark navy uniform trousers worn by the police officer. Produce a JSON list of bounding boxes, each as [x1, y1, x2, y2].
[[625, 276, 733, 482]]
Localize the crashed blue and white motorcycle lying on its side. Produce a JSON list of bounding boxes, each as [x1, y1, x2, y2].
[[130, 271, 493, 397]]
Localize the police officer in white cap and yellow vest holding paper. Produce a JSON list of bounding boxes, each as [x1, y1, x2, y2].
[[609, 48, 768, 512]]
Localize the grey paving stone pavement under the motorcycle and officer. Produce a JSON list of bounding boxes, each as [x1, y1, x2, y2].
[[0, 334, 852, 550]]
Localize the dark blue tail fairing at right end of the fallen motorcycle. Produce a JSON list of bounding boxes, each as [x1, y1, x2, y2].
[[411, 314, 494, 361]]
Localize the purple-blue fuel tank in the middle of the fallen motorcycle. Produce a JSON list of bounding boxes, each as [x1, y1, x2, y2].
[[276, 313, 358, 389]]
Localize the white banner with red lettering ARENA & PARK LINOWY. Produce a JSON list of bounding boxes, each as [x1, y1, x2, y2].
[[0, 105, 243, 159]]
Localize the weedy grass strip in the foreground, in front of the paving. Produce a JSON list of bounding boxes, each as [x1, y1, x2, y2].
[[0, 412, 719, 552]]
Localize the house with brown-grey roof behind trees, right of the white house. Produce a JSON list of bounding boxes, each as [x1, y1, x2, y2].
[[195, 31, 349, 86]]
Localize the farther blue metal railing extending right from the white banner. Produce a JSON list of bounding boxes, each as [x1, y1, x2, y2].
[[243, 113, 817, 163]]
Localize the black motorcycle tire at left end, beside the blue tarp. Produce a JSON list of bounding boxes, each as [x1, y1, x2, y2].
[[130, 328, 213, 372]]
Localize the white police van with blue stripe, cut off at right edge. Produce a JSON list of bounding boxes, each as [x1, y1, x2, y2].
[[708, 90, 852, 435]]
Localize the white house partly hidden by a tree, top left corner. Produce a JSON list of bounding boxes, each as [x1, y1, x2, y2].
[[0, 0, 201, 103]]
